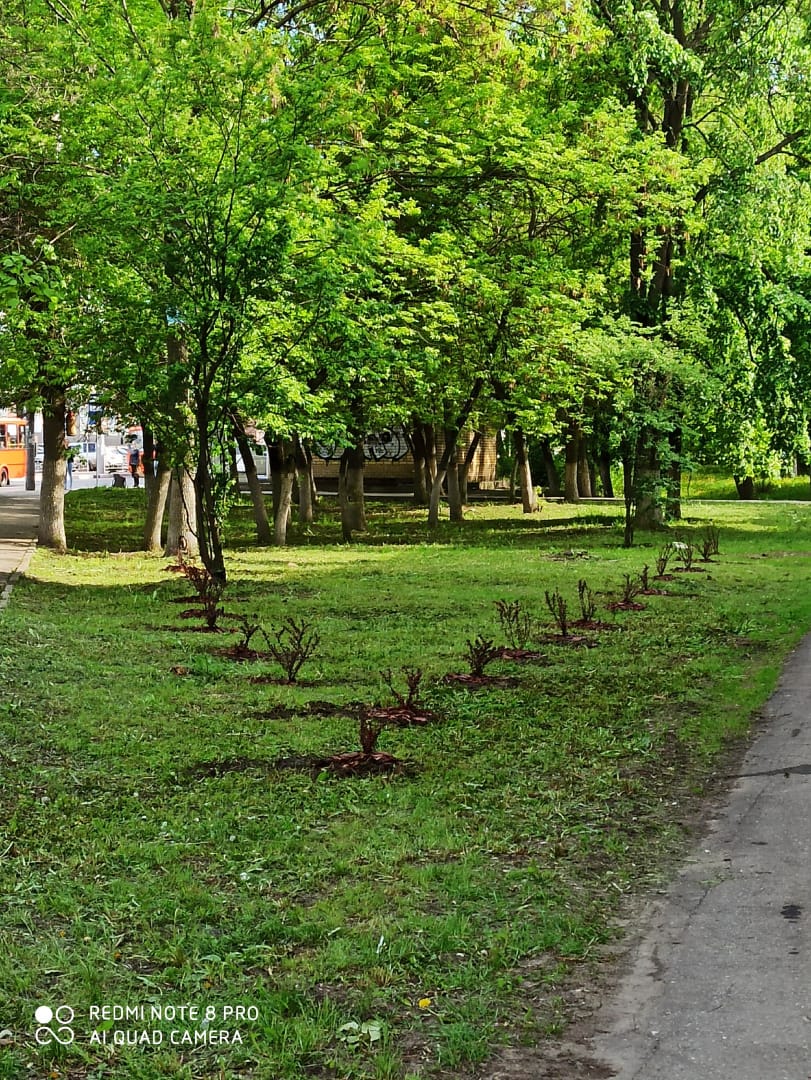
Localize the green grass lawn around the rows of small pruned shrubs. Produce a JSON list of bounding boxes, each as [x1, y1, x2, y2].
[[0, 489, 811, 1080]]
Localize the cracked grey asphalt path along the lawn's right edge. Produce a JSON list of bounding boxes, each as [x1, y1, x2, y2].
[[592, 637, 811, 1080]]
